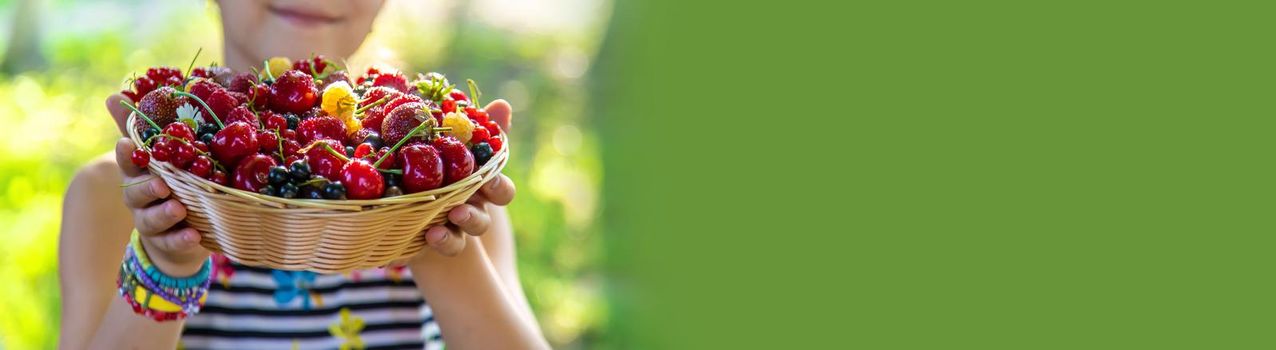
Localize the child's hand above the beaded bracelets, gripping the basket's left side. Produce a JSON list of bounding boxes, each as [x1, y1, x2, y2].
[[106, 95, 211, 276]]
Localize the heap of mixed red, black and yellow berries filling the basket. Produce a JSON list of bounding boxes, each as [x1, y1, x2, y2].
[[129, 56, 504, 199]]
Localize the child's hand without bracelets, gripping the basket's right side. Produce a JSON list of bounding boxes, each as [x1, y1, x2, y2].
[[425, 100, 516, 257]]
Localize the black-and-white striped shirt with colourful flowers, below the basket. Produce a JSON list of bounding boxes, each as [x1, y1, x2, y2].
[[179, 255, 443, 350]]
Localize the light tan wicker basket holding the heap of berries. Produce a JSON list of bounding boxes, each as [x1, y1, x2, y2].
[[128, 114, 509, 273]]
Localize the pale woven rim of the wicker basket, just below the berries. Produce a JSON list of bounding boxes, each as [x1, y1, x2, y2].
[[126, 112, 509, 210]]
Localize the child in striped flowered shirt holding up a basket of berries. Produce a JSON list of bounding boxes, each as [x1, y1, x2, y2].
[[59, 0, 547, 349]]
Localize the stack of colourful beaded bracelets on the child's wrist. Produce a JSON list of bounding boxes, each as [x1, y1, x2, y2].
[[116, 231, 212, 322]]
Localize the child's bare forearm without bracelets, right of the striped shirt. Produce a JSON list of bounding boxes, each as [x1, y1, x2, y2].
[[408, 236, 549, 349]]
